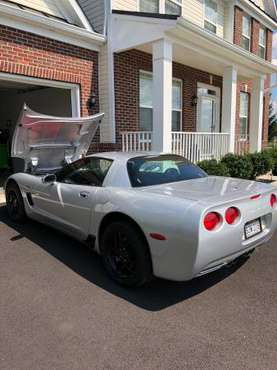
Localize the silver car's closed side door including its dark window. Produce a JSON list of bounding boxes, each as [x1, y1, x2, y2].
[[30, 157, 112, 239]]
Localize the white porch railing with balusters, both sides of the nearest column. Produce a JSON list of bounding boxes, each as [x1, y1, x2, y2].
[[122, 131, 230, 163]]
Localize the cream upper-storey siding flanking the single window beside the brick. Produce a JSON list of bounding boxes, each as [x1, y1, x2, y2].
[[183, 0, 225, 37]]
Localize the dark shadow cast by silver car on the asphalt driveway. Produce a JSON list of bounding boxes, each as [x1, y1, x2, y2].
[[0, 207, 245, 311]]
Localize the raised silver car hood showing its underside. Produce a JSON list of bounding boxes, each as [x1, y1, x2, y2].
[[11, 105, 104, 173]]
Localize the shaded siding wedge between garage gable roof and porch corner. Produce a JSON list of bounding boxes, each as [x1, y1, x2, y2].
[[78, 0, 105, 34]]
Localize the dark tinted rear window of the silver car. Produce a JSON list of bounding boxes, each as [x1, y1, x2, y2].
[[127, 155, 207, 188]]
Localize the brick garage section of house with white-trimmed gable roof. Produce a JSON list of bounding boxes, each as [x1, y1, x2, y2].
[[0, 0, 105, 167]]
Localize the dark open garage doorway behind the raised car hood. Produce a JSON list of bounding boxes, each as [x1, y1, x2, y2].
[[0, 79, 72, 181]]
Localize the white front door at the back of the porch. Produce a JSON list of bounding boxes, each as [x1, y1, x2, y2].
[[197, 87, 220, 133]]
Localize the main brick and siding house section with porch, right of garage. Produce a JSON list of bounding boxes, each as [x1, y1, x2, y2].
[[79, 0, 277, 161]]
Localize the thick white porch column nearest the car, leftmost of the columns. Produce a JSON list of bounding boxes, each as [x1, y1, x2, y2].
[[152, 39, 172, 153]]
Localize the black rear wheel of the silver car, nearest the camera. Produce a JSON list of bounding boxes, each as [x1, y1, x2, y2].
[[101, 221, 152, 287]]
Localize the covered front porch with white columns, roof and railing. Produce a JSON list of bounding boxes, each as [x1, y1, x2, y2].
[[112, 14, 276, 162]]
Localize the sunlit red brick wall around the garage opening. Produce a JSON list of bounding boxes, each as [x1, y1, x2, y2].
[[0, 26, 99, 116]]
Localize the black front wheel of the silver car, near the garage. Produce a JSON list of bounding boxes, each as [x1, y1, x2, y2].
[[6, 183, 27, 223]]
